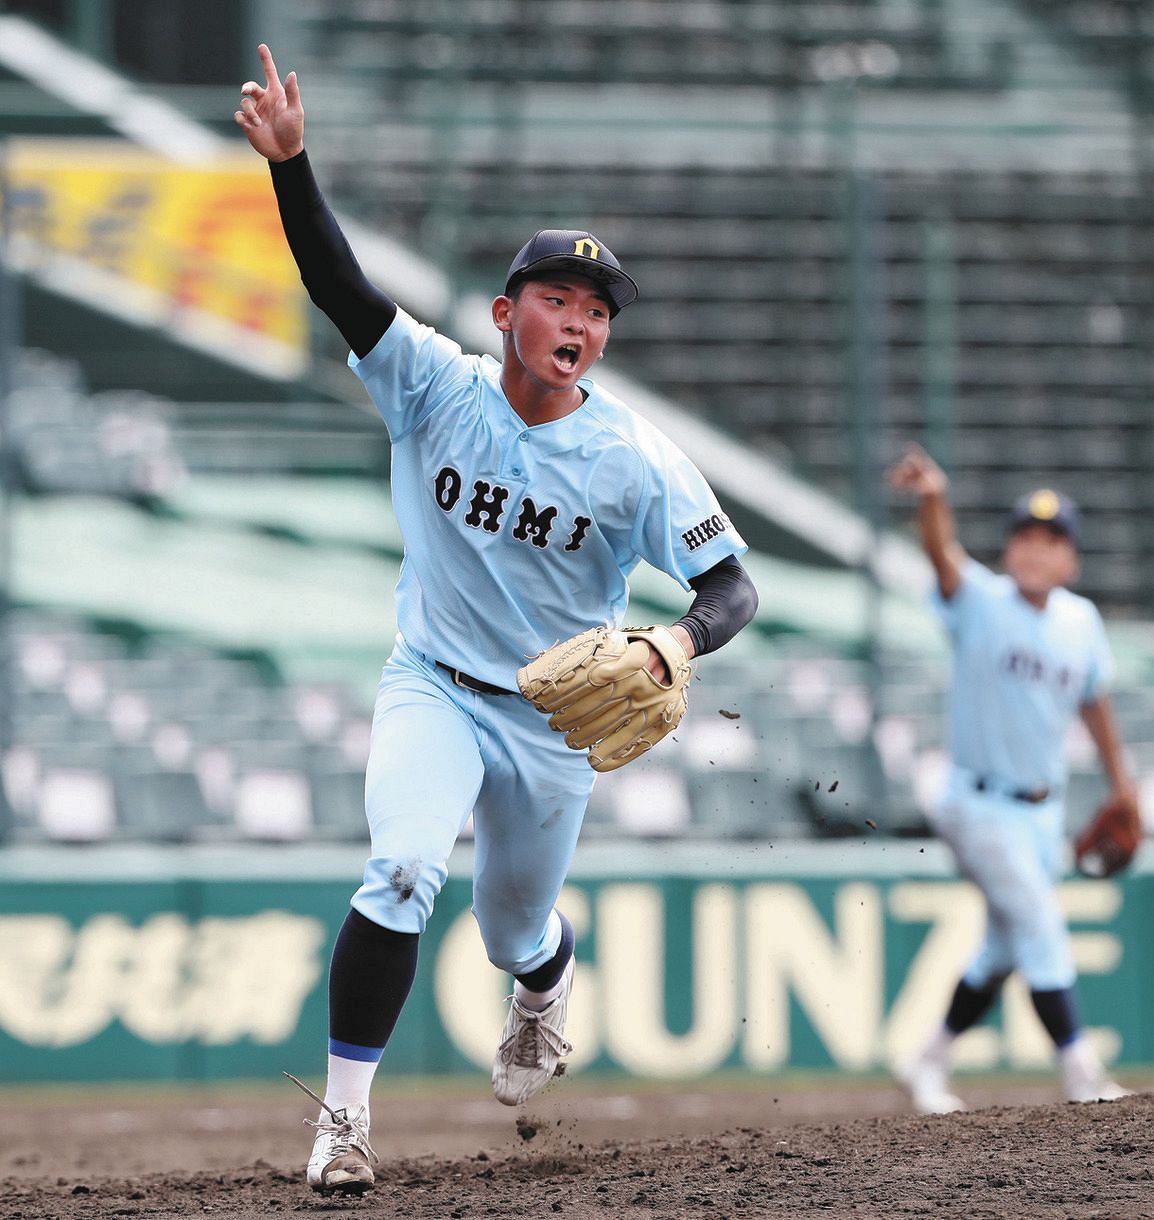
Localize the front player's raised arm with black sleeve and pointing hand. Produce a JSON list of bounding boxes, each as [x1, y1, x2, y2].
[[233, 43, 396, 356]]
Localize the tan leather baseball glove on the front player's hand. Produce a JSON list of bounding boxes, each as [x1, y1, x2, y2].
[[517, 627, 693, 771]]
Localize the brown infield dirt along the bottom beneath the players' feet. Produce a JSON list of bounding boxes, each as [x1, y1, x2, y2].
[[0, 1081, 1154, 1220]]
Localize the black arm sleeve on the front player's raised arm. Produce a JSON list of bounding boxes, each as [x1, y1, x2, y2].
[[268, 151, 396, 356]]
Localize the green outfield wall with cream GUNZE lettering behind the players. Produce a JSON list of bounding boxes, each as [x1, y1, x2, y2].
[[0, 839, 1154, 1082]]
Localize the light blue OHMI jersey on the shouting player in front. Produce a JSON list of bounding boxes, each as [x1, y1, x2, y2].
[[349, 310, 747, 688]]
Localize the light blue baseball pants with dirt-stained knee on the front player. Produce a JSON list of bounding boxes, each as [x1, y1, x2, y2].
[[353, 637, 595, 975]]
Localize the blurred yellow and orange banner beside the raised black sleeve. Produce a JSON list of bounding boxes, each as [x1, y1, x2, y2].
[[6, 139, 306, 351]]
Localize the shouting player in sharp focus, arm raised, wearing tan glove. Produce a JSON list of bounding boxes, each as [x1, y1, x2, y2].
[[234, 45, 756, 1193]]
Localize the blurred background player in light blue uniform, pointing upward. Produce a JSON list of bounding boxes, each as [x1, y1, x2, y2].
[[888, 445, 1138, 1114]]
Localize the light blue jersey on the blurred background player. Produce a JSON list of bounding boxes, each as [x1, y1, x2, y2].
[[933, 559, 1113, 789]]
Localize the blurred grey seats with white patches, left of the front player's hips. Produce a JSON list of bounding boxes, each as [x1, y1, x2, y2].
[[4, 610, 368, 842]]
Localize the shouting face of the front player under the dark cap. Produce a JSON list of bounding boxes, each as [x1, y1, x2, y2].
[[493, 272, 609, 390]]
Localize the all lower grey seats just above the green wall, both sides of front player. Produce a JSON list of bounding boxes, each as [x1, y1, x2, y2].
[[0, 592, 1154, 844]]
